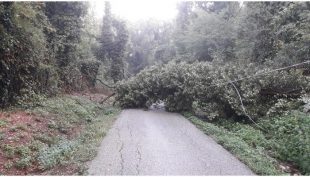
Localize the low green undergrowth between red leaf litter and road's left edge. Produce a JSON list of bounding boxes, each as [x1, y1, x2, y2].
[[32, 97, 120, 175]]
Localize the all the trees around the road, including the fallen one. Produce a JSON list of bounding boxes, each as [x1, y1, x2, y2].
[[0, 1, 310, 174]]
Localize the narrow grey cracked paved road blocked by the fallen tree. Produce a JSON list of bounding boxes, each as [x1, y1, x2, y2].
[[88, 109, 254, 175]]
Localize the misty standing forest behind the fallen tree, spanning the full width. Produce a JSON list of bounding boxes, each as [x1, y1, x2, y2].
[[0, 2, 309, 108]]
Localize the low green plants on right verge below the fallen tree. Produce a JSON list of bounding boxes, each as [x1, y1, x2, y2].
[[182, 112, 310, 176]]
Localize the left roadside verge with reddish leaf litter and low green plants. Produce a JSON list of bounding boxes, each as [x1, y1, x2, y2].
[[0, 95, 120, 175]]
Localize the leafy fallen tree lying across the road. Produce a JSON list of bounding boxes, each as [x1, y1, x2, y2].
[[116, 61, 309, 120]]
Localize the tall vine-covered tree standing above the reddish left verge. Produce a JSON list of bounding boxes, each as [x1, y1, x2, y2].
[[46, 2, 88, 90]]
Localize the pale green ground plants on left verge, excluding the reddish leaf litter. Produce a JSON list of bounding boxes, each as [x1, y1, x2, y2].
[[22, 96, 120, 174]]
